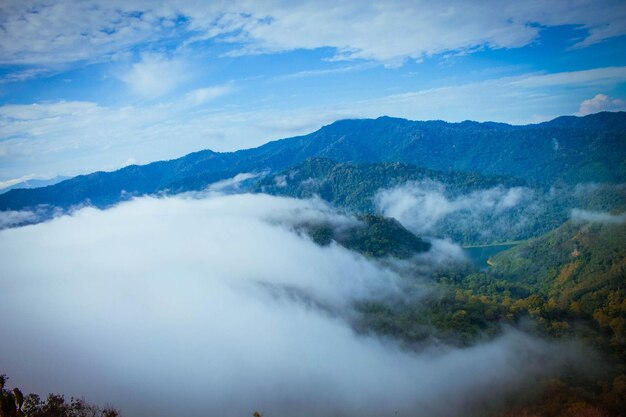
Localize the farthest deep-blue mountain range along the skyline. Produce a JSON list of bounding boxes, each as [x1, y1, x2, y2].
[[0, 112, 626, 210]]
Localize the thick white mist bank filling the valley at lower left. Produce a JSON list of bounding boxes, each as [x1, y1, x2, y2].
[[0, 193, 576, 417]]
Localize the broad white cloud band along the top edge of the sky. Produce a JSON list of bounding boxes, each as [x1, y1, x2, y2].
[[0, 0, 626, 65]]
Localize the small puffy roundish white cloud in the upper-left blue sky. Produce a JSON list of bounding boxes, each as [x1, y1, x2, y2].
[[120, 53, 190, 99]]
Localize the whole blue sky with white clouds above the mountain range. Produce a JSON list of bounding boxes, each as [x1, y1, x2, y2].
[[0, 0, 626, 188]]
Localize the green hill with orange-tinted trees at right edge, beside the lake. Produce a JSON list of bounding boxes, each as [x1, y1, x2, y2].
[[491, 221, 626, 350]]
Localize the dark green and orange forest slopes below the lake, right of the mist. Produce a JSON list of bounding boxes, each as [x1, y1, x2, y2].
[[356, 222, 626, 417]]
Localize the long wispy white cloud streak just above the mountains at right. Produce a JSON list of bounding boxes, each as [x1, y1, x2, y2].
[[353, 67, 626, 124]]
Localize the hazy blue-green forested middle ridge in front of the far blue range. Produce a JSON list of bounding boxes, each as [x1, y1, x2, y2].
[[253, 158, 626, 245]]
